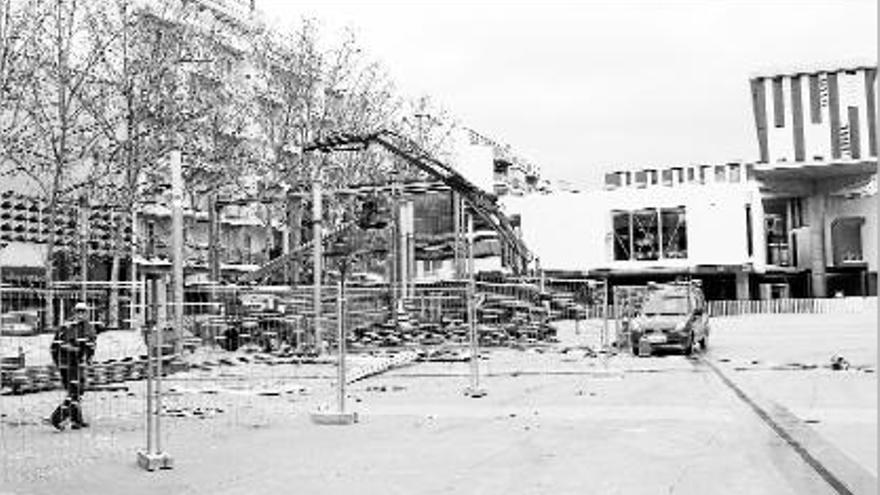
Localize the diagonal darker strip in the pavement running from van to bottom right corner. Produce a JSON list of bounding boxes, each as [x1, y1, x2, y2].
[[702, 358, 878, 495]]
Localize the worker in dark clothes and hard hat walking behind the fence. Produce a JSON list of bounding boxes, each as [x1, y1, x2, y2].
[[49, 302, 97, 430]]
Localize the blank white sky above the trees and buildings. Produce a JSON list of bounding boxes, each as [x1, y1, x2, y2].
[[257, 0, 877, 184]]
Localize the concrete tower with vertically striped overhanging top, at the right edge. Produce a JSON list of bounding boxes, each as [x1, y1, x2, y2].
[[751, 64, 877, 297]]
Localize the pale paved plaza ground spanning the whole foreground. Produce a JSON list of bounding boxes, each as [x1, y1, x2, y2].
[[0, 314, 877, 494]]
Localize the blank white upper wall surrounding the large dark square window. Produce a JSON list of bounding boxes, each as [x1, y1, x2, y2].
[[503, 183, 764, 270]]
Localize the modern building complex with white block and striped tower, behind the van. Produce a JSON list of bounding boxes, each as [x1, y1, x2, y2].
[[502, 65, 878, 299]]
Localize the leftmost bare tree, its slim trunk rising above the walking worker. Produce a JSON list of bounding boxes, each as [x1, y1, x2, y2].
[[8, 0, 123, 325]]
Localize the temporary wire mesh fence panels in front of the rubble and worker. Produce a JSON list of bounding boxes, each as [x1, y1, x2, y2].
[[0, 281, 604, 481]]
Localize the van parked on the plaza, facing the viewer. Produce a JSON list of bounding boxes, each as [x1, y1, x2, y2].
[[630, 283, 709, 355]]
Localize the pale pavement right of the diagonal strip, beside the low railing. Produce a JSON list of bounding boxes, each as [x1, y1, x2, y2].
[[708, 312, 877, 477]]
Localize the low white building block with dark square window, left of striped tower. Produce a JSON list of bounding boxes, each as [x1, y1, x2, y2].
[[505, 162, 767, 299]]
